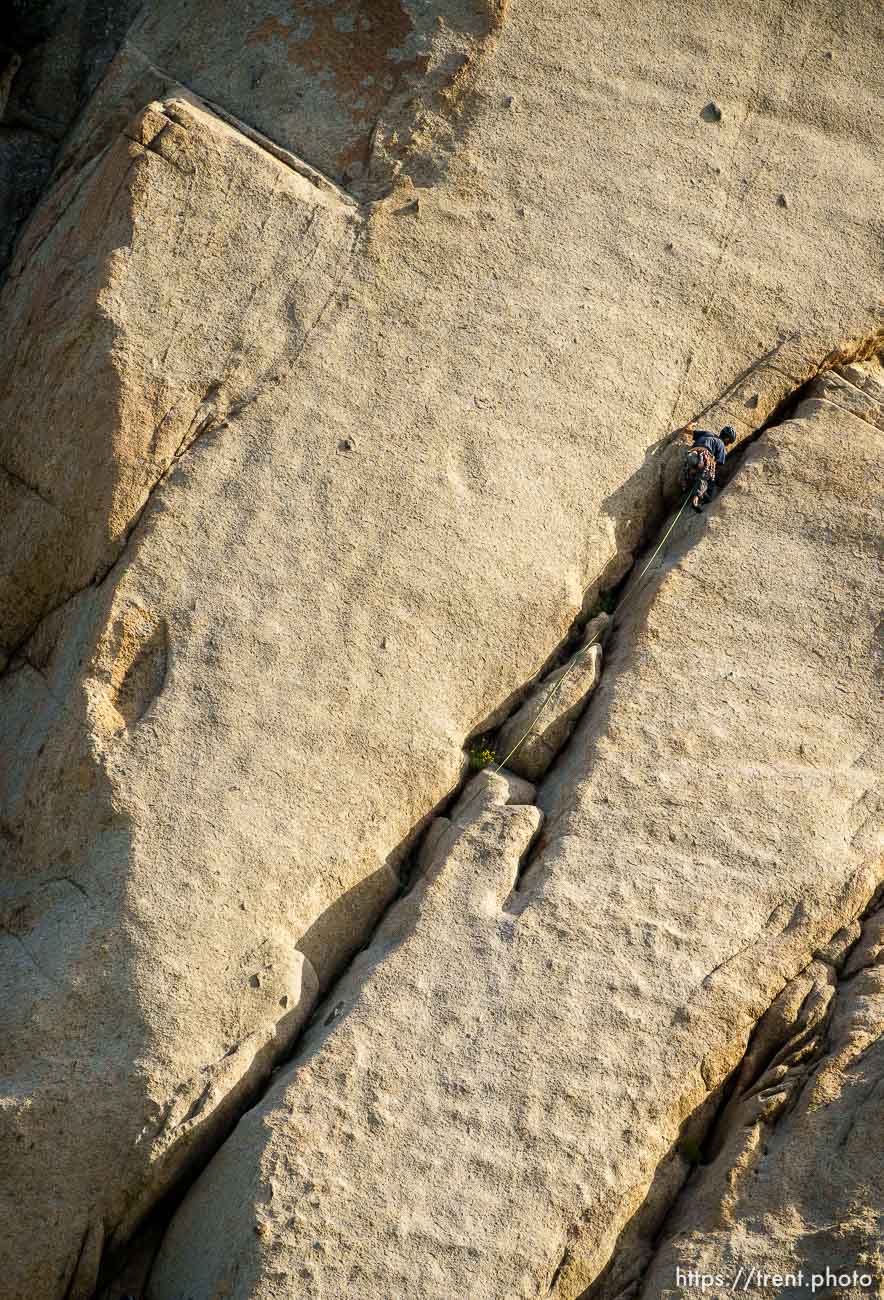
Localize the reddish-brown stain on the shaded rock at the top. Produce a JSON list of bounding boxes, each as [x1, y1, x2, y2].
[[246, 0, 428, 173]]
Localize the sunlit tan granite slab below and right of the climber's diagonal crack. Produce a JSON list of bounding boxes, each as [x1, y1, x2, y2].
[[151, 369, 884, 1300]]
